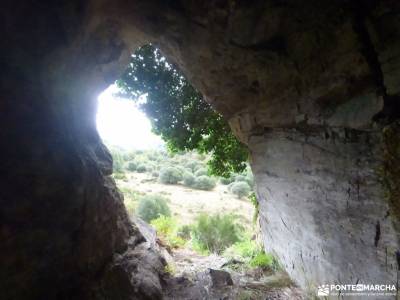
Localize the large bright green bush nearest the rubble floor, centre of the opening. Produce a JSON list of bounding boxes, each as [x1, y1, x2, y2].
[[192, 214, 243, 254]]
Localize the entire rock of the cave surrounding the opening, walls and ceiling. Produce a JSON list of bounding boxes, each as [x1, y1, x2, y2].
[[0, 0, 400, 299]]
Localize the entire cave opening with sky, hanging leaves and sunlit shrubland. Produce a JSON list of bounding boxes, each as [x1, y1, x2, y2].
[[96, 45, 291, 297]]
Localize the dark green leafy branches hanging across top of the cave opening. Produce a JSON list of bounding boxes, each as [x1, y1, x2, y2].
[[117, 45, 248, 177]]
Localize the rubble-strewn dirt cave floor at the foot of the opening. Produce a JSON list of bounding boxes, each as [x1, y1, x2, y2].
[[165, 249, 305, 300]]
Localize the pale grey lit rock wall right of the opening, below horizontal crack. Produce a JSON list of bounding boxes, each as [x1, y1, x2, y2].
[[250, 128, 398, 291]]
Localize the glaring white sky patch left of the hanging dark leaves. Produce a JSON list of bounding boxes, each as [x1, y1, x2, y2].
[[96, 85, 164, 150]]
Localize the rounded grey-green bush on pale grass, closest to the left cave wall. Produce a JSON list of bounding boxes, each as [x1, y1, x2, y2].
[[137, 194, 171, 222]]
